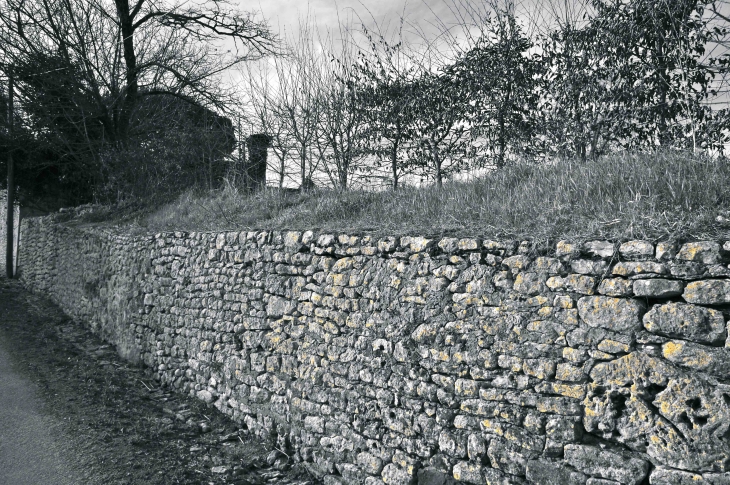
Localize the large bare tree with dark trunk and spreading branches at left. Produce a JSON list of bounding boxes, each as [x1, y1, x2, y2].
[[0, 0, 277, 200]]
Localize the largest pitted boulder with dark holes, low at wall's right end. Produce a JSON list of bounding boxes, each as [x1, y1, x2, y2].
[[583, 352, 730, 472]]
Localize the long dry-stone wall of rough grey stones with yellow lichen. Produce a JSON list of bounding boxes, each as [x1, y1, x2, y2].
[[15, 218, 730, 485]]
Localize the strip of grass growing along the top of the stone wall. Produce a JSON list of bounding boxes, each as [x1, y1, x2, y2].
[[116, 152, 730, 241]]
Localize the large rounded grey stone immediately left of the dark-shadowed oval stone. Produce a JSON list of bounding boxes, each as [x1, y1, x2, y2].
[[578, 296, 644, 332]]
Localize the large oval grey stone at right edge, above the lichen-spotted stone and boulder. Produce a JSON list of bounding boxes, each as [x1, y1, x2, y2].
[[644, 303, 727, 344]]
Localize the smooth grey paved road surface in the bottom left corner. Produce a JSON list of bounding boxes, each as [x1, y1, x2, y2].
[[0, 306, 84, 485]]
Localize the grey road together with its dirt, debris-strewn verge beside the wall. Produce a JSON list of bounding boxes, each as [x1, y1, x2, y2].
[[0, 279, 316, 485]]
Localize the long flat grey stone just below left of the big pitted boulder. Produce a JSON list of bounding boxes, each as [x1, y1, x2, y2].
[[565, 444, 649, 485]]
